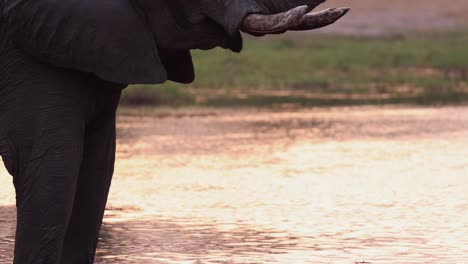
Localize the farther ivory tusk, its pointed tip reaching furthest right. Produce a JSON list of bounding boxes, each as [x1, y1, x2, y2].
[[290, 7, 351, 31]]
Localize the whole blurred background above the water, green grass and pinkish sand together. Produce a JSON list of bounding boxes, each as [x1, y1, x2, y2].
[[123, 0, 468, 106]]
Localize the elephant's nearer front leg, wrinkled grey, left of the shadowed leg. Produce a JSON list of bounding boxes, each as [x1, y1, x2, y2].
[[10, 87, 90, 264]]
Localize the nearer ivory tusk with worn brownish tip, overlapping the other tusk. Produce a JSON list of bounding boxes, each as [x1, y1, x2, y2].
[[241, 5, 309, 34]]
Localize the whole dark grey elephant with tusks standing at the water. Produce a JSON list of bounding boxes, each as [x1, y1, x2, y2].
[[0, 0, 349, 264]]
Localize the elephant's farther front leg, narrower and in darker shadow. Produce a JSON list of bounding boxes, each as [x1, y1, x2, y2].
[[61, 90, 120, 264]]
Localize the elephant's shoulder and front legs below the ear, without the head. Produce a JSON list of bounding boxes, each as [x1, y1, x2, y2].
[[0, 14, 125, 264]]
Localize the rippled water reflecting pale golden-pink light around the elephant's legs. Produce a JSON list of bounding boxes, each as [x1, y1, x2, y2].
[[0, 107, 468, 264]]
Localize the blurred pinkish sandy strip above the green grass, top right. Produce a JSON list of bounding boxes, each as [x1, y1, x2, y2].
[[319, 0, 468, 36]]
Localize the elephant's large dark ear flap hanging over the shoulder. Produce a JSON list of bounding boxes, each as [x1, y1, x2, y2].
[[9, 0, 167, 84]]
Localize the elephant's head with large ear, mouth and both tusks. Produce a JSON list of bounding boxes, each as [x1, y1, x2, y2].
[[5, 0, 348, 84]]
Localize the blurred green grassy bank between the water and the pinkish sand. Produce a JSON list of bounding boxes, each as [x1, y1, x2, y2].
[[123, 31, 468, 106]]
